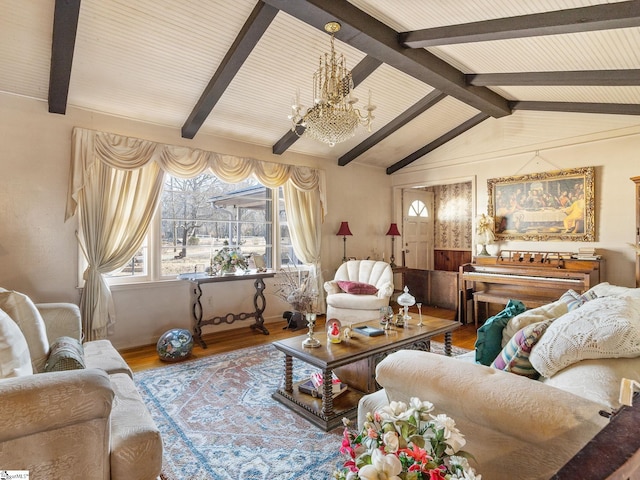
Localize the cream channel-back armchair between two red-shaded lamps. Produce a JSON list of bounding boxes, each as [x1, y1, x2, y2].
[[324, 260, 393, 323]]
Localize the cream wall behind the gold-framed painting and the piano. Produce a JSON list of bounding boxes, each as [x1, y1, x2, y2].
[[393, 112, 640, 286]]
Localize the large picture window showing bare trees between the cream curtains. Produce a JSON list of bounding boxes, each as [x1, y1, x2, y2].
[[100, 174, 301, 283]]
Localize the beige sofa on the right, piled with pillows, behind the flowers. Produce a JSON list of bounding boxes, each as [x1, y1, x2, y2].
[[358, 284, 640, 480]]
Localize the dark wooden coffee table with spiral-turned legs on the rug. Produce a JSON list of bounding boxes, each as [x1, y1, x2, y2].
[[272, 315, 460, 431]]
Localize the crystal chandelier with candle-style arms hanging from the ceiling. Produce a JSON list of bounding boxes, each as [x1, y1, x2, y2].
[[289, 22, 376, 147]]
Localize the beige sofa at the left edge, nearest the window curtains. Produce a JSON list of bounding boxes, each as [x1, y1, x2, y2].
[[0, 289, 163, 480]]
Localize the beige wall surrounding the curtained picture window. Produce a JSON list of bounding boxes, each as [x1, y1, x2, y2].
[[0, 94, 392, 348]]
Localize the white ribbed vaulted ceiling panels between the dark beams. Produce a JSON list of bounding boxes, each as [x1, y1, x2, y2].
[[0, 0, 640, 172]]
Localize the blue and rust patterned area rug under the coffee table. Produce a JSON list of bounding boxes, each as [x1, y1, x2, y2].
[[134, 342, 465, 480]]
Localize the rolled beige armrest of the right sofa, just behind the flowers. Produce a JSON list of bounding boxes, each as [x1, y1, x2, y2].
[[376, 350, 607, 444]]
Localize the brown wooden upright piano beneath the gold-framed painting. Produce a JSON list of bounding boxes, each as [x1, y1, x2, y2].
[[458, 250, 602, 326]]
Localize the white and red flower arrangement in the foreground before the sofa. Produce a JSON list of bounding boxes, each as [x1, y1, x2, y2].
[[333, 397, 482, 480]]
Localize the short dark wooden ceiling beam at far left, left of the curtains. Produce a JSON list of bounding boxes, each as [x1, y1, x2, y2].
[[49, 0, 80, 115]]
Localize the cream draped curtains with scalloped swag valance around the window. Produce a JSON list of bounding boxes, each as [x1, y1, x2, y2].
[[65, 128, 326, 340]]
